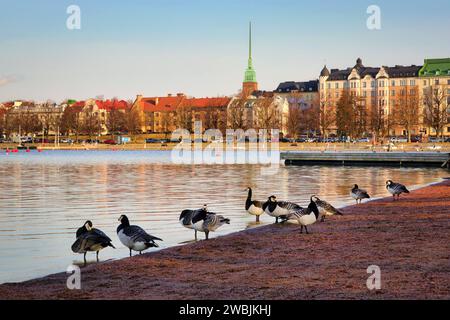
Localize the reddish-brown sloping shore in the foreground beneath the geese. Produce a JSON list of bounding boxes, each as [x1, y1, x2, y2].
[[0, 180, 450, 300]]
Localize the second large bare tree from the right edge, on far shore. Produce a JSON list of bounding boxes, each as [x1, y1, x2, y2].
[[392, 86, 419, 142]]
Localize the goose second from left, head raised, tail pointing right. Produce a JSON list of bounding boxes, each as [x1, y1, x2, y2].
[[117, 215, 163, 257]]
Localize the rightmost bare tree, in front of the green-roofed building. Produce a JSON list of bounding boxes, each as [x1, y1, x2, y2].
[[423, 85, 449, 137]]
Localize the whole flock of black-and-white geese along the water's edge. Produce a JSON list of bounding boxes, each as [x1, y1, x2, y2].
[[72, 180, 409, 264]]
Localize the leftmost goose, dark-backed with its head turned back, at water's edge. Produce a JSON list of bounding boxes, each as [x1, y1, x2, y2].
[[72, 220, 115, 265]]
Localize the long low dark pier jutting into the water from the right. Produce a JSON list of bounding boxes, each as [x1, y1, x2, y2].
[[281, 151, 450, 169]]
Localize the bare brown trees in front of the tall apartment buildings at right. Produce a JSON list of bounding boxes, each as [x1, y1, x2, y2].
[[319, 86, 450, 141]]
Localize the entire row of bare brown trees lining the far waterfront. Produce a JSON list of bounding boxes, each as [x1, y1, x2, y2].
[[0, 86, 450, 140]]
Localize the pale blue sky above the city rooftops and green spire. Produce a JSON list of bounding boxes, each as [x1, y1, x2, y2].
[[0, 0, 450, 101]]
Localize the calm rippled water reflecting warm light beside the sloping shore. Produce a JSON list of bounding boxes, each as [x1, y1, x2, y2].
[[0, 151, 448, 283]]
